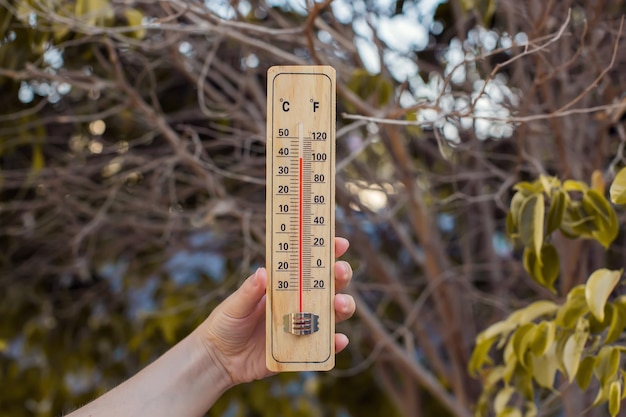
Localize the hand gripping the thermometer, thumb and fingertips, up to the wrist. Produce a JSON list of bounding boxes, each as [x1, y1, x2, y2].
[[194, 238, 356, 385]]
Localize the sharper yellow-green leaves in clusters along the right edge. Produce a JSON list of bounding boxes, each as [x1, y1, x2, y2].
[[468, 168, 626, 417]]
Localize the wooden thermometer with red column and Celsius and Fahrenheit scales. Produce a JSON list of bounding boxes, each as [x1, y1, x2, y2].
[[266, 66, 336, 372]]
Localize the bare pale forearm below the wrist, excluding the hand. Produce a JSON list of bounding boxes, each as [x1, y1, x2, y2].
[[68, 332, 230, 417]]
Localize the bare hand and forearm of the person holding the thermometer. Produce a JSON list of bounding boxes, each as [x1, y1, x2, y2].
[[68, 238, 356, 417]]
